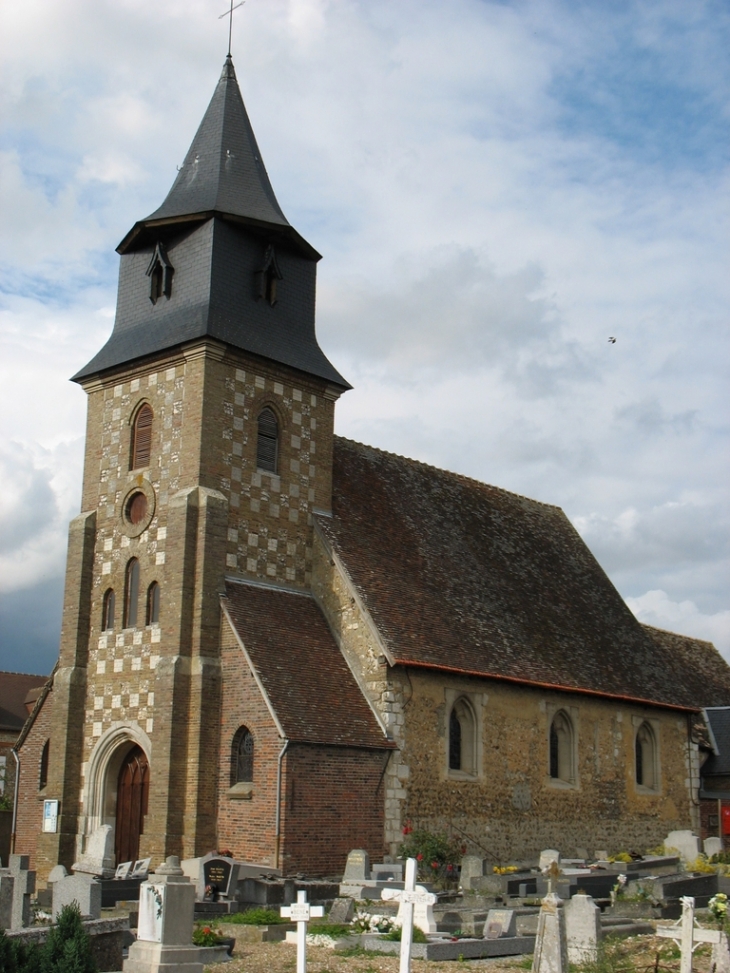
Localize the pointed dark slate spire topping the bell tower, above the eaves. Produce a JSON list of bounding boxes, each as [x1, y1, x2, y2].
[[144, 54, 289, 226]]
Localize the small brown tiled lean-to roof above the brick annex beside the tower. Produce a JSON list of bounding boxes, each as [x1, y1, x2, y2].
[[223, 581, 393, 748]]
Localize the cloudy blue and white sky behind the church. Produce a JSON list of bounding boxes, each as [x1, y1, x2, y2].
[[0, 0, 730, 673]]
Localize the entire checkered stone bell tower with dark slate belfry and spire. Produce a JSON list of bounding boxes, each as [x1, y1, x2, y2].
[[38, 55, 349, 872]]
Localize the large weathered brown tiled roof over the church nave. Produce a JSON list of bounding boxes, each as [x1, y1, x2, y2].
[[318, 437, 728, 709]]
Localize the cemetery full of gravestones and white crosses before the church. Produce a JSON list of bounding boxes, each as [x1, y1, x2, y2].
[[0, 828, 730, 973]]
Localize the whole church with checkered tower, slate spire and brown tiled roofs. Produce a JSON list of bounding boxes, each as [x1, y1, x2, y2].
[[15, 55, 730, 880]]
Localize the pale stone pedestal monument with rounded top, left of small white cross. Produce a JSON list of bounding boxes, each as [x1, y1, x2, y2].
[[123, 856, 203, 973]]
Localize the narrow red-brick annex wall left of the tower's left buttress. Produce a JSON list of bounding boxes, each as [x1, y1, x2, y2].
[[15, 692, 55, 870]]
